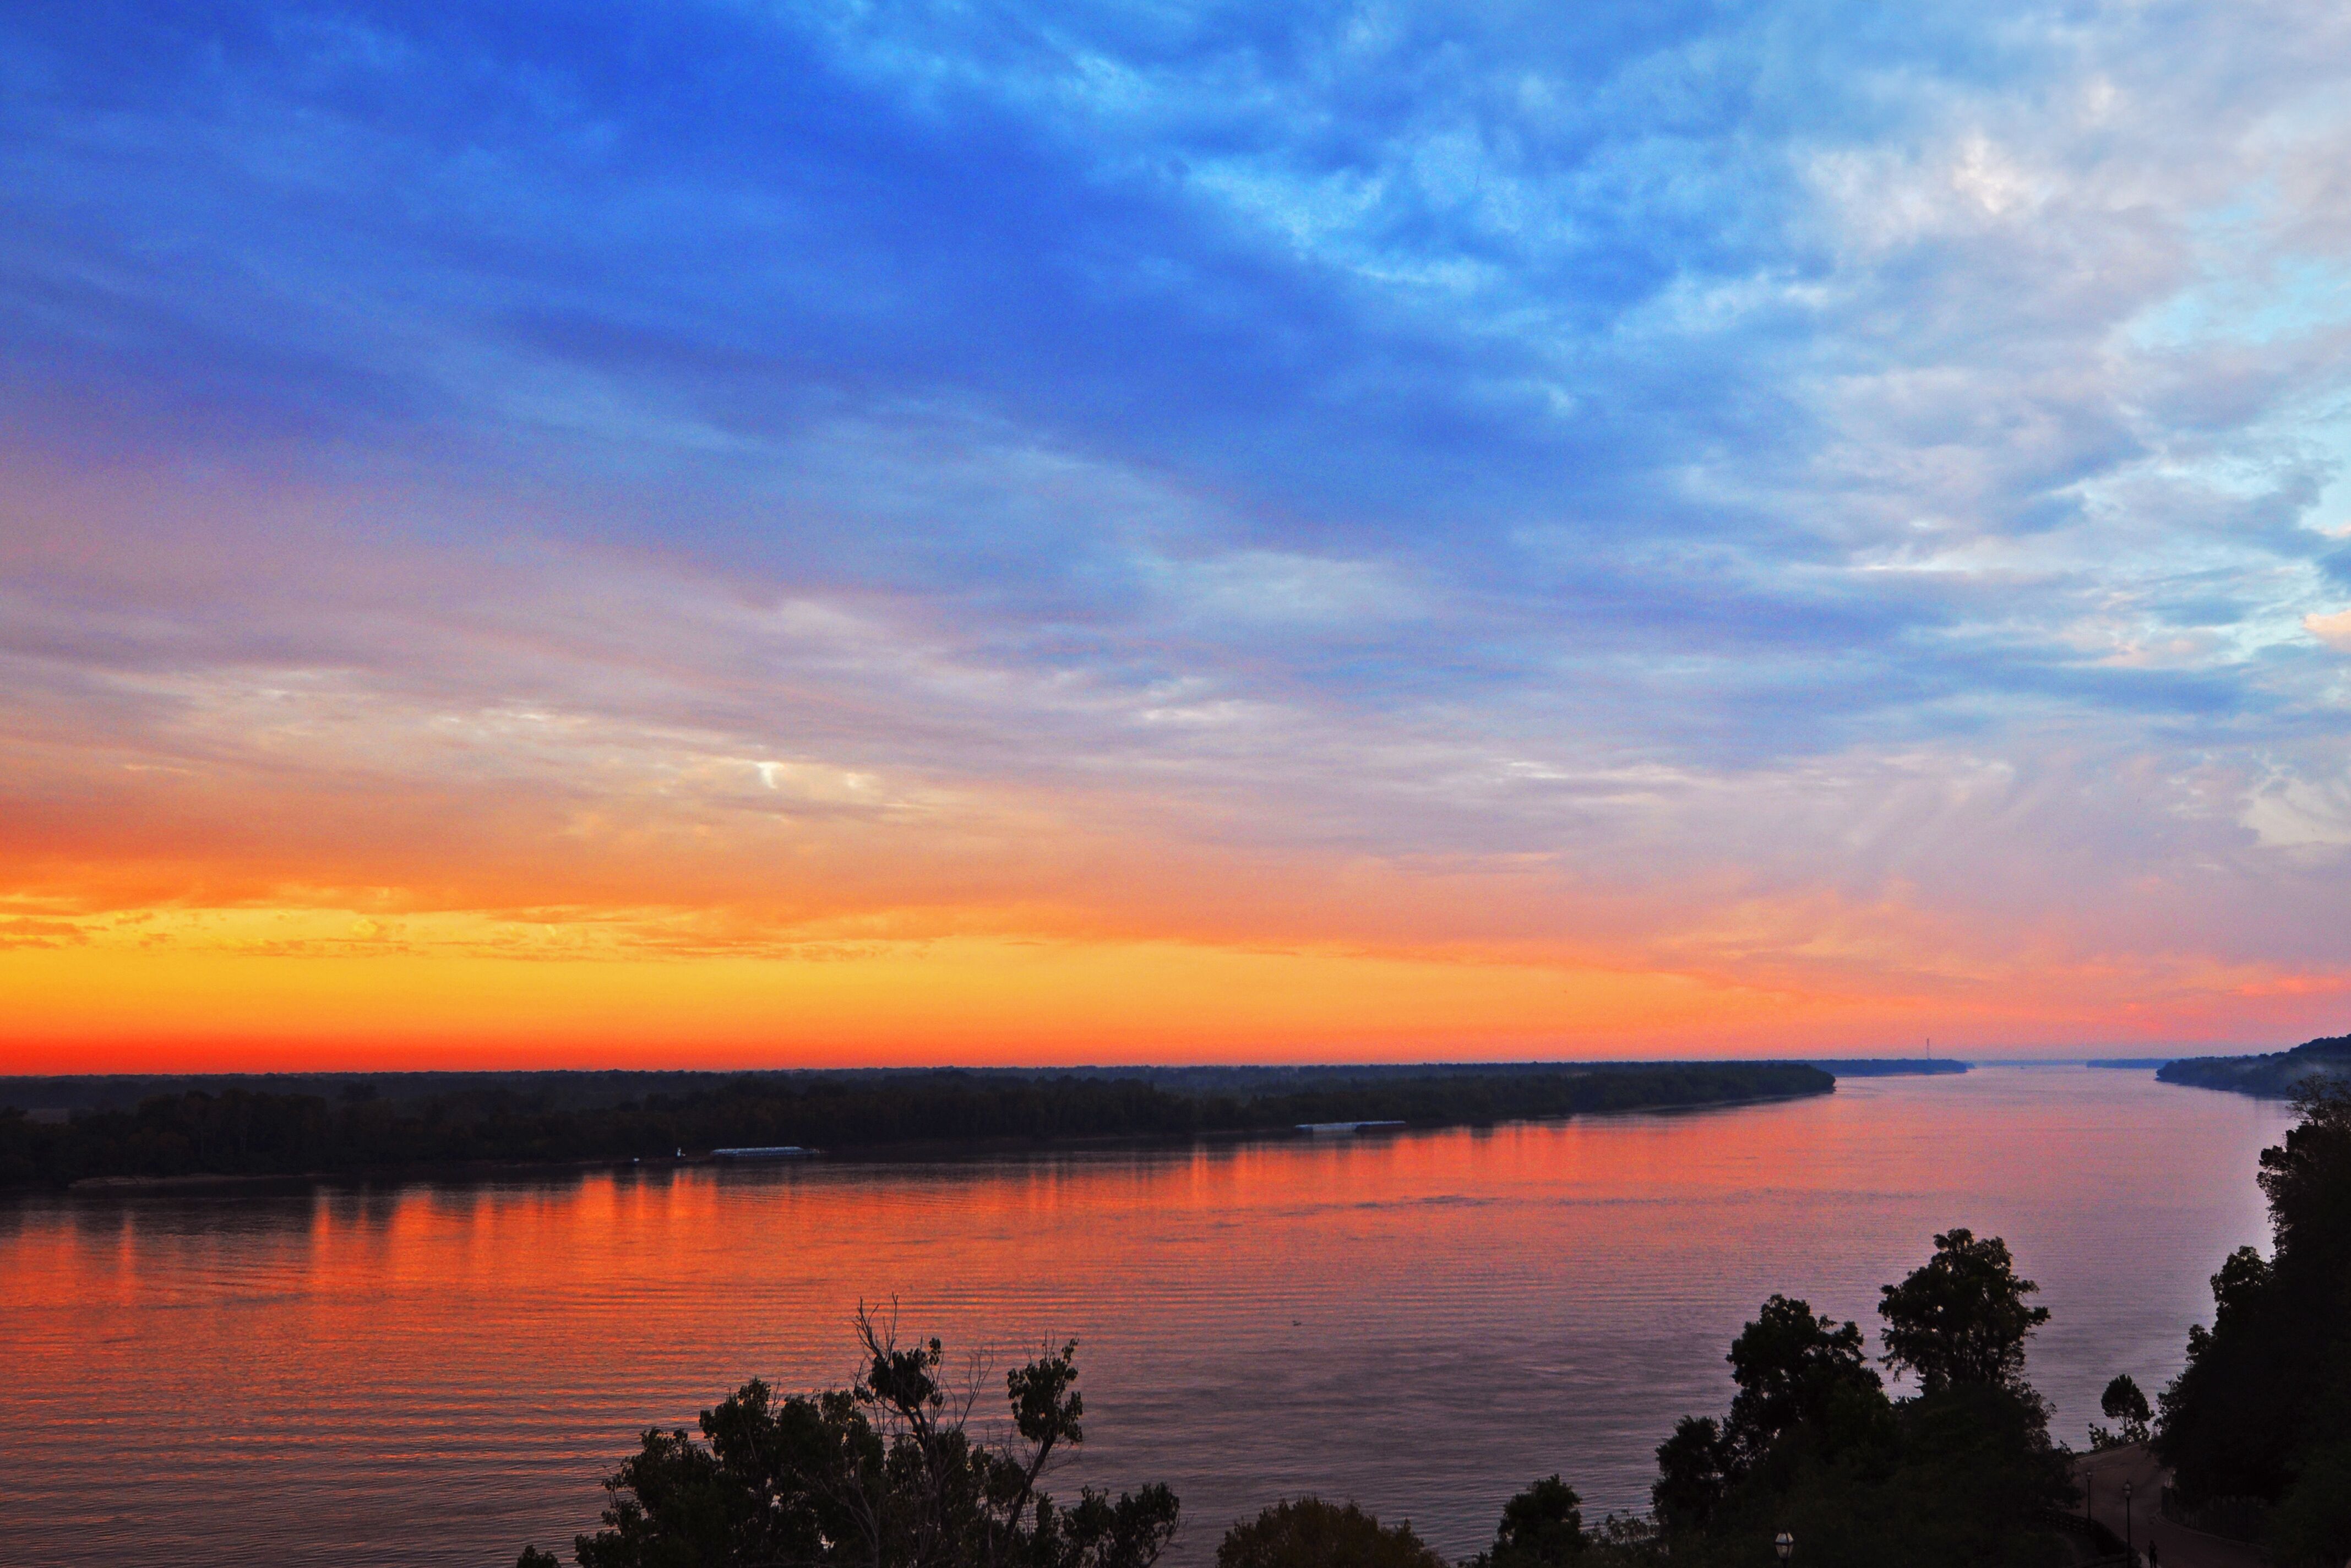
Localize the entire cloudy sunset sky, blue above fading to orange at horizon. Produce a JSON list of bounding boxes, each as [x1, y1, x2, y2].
[[0, 0, 2351, 1072]]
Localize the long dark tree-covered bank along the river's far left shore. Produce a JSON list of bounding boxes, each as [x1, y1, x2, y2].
[[0, 1063, 1836, 1187]]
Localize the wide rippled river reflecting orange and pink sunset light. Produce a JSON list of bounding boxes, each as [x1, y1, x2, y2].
[[0, 1068, 2290, 1568]]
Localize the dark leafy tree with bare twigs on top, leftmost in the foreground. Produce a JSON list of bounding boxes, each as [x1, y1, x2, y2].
[[520, 1312, 1178, 1568]]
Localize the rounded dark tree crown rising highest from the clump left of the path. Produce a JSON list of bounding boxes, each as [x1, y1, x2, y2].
[[1879, 1229, 2050, 1394]]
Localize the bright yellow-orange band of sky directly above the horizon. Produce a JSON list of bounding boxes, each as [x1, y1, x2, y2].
[[0, 912, 2342, 1072]]
